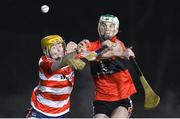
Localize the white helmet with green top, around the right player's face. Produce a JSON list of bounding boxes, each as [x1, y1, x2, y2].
[[98, 14, 119, 40]]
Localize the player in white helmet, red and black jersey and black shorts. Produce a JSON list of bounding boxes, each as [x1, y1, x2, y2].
[[78, 14, 136, 118]]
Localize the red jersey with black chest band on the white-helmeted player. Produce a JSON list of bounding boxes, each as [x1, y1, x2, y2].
[[88, 37, 136, 101]]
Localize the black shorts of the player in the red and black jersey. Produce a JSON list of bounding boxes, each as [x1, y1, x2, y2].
[[93, 98, 132, 117]]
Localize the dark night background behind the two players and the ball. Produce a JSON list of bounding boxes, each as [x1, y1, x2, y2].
[[0, 0, 180, 118]]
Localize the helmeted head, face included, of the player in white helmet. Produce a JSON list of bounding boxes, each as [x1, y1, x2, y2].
[[98, 15, 119, 40]]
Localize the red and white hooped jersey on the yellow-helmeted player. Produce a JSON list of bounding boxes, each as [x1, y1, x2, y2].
[[31, 56, 74, 117]]
